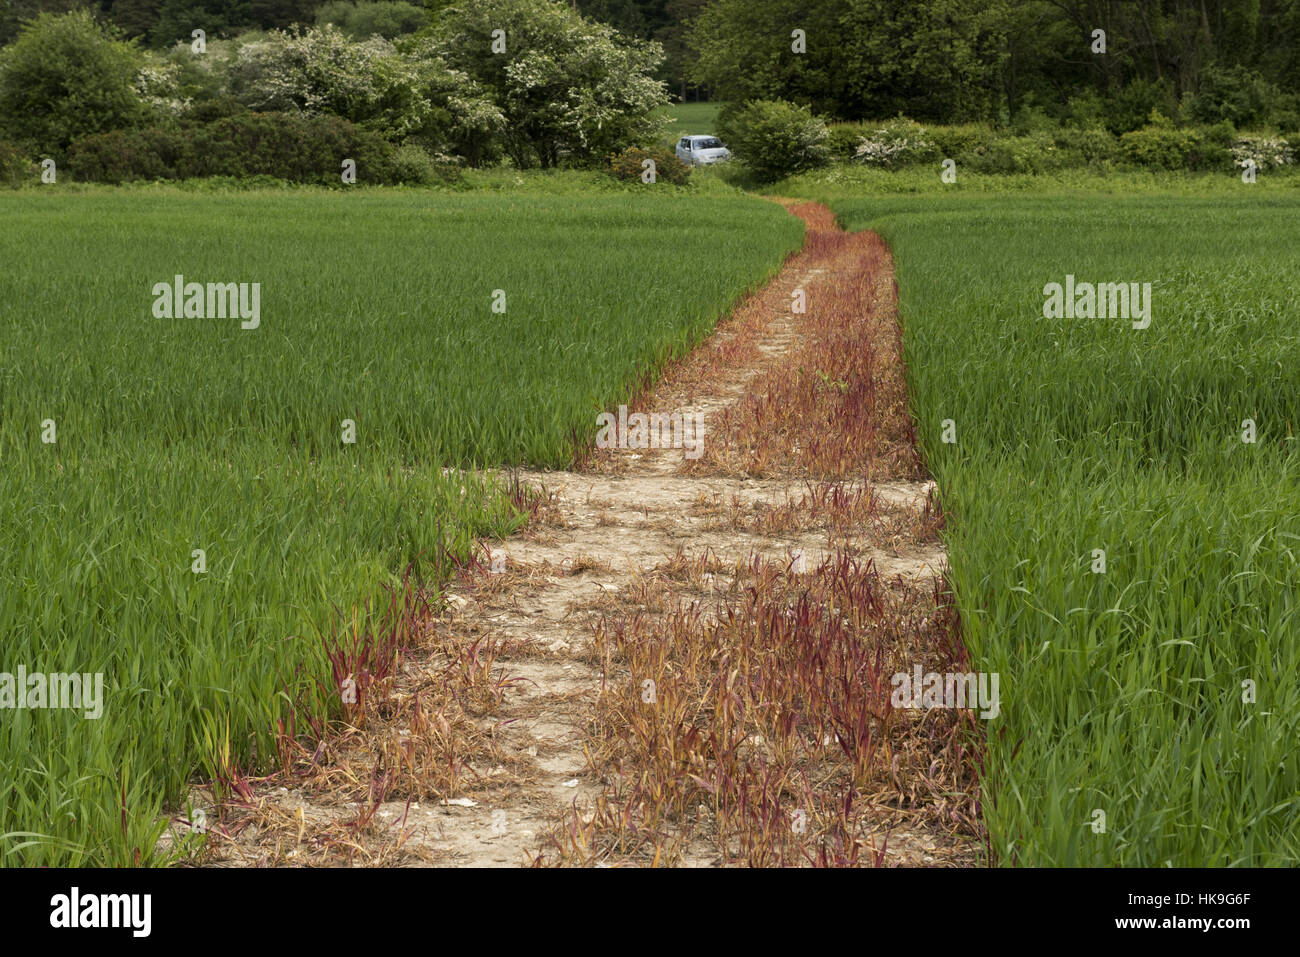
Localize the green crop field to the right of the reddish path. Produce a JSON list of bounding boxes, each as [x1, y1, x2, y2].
[[833, 195, 1300, 866]]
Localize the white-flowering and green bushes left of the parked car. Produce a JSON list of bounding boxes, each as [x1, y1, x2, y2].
[[0, 7, 667, 182]]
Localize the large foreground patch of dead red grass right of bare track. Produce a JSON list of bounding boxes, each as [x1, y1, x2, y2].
[[538, 553, 979, 866]]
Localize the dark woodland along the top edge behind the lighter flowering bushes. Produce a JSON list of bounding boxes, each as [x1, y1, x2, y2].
[[0, 0, 1300, 131]]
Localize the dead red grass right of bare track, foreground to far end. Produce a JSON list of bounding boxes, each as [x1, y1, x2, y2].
[[537, 203, 980, 866]]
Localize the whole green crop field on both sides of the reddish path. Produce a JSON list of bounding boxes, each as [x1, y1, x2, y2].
[[0, 183, 1300, 866]]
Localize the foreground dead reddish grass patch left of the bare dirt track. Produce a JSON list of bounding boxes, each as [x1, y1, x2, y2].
[[186, 561, 541, 866]]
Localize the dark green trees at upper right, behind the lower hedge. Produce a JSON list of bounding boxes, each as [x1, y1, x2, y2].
[[681, 0, 1300, 135]]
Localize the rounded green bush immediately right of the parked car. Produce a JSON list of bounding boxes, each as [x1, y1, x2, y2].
[[718, 100, 831, 182]]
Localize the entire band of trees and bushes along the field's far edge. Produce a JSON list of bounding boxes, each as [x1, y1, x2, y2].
[[0, 0, 1300, 188]]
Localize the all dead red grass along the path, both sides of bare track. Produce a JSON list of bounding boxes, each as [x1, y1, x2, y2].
[[178, 203, 980, 866]]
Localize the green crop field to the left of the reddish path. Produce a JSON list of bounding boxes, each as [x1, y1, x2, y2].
[[0, 190, 802, 865]]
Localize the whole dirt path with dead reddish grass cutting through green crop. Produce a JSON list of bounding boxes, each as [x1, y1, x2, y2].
[[189, 204, 978, 866]]
